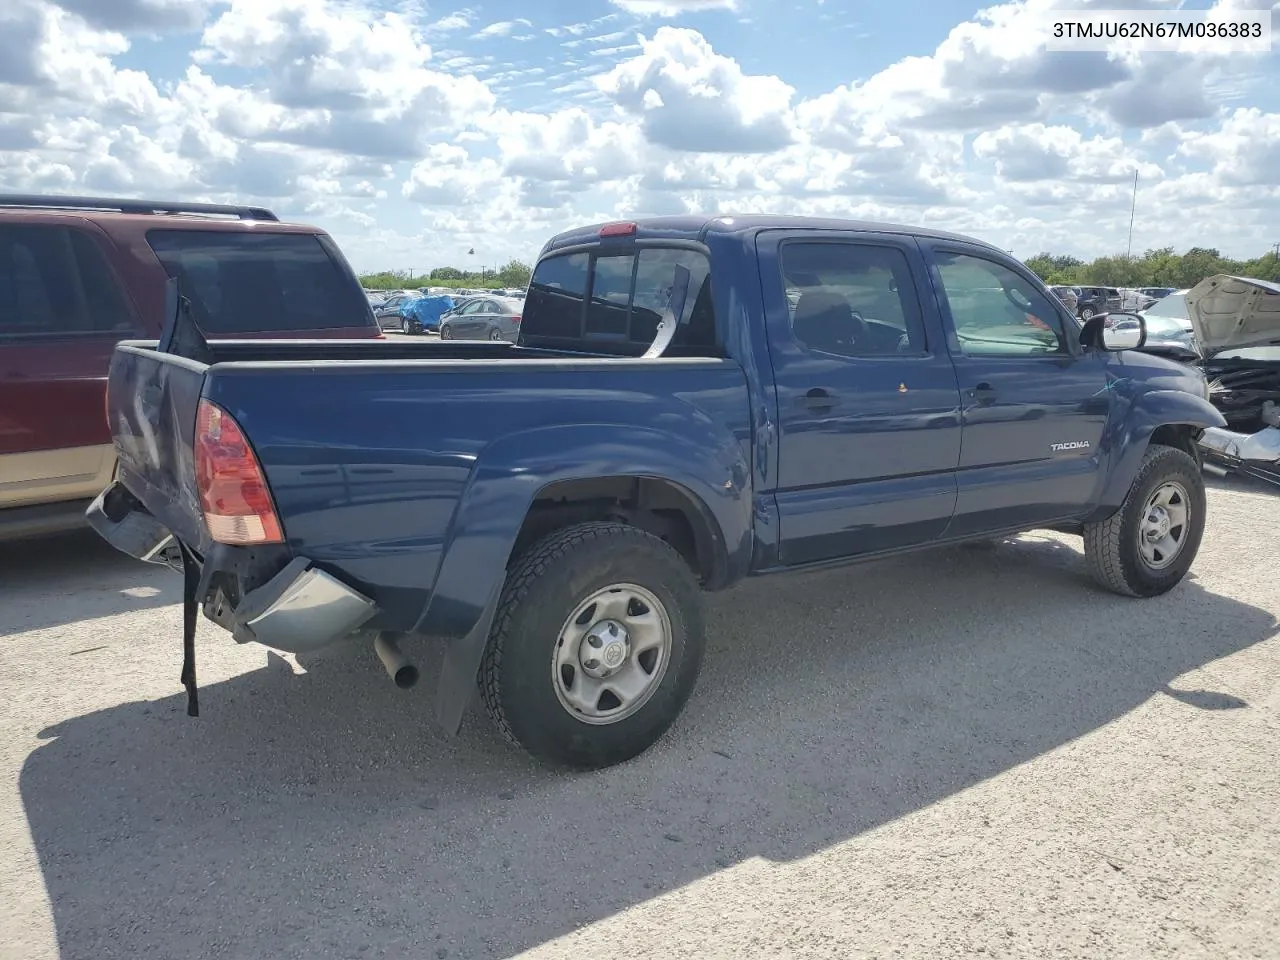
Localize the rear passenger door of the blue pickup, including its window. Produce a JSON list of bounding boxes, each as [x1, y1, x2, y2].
[[756, 230, 960, 564]]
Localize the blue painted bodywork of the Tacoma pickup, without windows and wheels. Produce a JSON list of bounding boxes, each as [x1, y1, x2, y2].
[[109, 218, 1224, 706]]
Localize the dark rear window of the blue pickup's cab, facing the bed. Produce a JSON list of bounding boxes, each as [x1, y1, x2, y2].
[[520, 247, 721, 357]]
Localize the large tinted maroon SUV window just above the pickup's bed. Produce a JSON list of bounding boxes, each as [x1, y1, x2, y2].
[[147, 230, 372, 335]]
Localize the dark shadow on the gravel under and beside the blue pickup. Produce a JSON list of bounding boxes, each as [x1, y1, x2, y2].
[[20, 536, 1276, 960]]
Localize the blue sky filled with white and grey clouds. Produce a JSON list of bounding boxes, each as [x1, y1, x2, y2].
[[0, 0, 1280, 271]]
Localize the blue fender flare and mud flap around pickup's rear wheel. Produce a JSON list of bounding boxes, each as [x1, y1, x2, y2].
[[424, 424, 753, 733]]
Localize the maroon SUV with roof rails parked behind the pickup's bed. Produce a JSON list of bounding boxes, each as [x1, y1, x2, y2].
[[0, 195, 381, 539]]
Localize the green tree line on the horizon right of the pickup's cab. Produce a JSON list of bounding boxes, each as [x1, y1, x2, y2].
[[1023, 247, 1280, 289]]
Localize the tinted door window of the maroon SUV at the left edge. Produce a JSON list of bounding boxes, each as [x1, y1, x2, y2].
[[0, 224, 140, 340]]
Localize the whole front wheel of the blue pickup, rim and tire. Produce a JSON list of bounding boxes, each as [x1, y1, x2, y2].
[[1084, 444, 1206, 596]]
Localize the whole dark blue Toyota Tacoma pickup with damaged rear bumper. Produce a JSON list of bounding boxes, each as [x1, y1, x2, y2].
[[88, 216, 1224, 768]]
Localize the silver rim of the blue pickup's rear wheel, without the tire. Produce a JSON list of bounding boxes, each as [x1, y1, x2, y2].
[[552, 584, 671, 726]]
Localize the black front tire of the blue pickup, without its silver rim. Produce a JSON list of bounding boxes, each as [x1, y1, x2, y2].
[[1084, 444, 1206, 596]]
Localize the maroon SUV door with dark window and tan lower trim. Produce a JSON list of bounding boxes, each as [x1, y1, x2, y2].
[[0, 221, 142, 508]]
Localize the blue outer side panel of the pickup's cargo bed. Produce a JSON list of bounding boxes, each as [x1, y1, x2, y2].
[[205, 360, 751, 636]]
